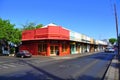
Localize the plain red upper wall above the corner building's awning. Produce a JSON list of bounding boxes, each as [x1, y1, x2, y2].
[[22, 26, 69, 41]]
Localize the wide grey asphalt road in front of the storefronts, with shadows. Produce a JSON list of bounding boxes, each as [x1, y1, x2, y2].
[[0, 52, 115, 80]]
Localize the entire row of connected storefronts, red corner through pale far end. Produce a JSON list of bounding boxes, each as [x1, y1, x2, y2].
[[20, 24, 106, 56]]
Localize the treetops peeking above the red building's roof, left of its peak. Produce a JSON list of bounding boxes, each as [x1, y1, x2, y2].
[[22, 22, 43, 30]]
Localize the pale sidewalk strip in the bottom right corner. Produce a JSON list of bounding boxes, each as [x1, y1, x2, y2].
[[104, 55, 120, 80]]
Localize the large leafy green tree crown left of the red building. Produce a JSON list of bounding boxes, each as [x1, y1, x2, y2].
[[0, 18, 21, 43]]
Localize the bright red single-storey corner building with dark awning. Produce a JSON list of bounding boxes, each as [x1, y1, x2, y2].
[[20, 24, 70, 56]]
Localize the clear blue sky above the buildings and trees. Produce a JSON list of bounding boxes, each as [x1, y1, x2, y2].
[[0, 0, 120, 40]]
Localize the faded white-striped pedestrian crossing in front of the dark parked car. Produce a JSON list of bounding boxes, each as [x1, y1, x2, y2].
[[0, 59, 59, 70]]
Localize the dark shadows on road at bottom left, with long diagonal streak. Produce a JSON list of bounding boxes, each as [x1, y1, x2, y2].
[[0, 60, 63, 80]]
